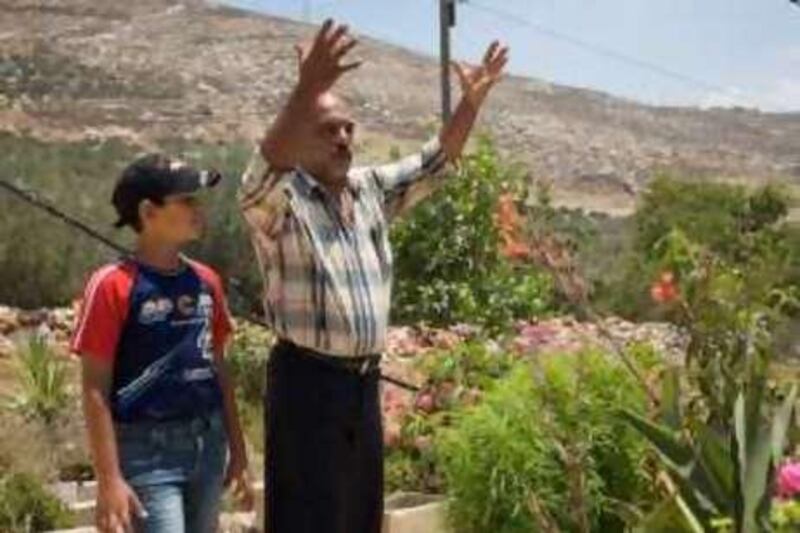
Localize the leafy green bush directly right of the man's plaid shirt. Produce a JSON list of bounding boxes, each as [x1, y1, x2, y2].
[[392, 139, 552, 331]]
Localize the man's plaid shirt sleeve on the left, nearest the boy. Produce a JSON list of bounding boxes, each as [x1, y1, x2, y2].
[[238, 147, 290, 235]]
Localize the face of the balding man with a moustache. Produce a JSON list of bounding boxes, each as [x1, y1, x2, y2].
[[300, 93, 355, 185]]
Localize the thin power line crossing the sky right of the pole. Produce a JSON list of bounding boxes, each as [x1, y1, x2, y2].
[[464, 1, 752, 106]]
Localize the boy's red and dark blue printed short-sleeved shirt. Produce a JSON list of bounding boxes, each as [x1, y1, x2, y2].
[[71, 259, 232, 422]]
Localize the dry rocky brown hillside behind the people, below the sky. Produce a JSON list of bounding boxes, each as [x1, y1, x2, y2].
[[0, 0, 800, 212]]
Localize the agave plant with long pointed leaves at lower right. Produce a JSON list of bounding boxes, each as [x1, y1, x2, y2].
[[622, 369, 798, 533]]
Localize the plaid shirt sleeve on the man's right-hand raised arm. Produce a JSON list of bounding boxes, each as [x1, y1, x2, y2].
[[358, 138, 449, 220]]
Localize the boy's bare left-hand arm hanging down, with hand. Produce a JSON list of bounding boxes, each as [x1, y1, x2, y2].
[[81, 354, 146, 532]]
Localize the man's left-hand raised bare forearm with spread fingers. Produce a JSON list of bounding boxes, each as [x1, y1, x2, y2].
[[260, 19, 361, 173]]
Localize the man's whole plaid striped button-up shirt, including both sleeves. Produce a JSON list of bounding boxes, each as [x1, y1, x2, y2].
[[239, 139, 447, 356]]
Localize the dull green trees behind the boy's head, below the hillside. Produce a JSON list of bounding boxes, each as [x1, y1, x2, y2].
[[0, 133, 261, 312]]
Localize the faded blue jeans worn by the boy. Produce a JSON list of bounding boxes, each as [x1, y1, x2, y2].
[[115, 413, 228, 533]]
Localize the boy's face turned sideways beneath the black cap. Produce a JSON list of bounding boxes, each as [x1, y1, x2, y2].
[[139, 194, 205, 245]]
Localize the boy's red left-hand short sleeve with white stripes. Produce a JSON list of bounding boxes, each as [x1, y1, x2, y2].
[[70, 264, 130, 362]]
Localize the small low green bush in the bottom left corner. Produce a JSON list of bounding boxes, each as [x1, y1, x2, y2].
[[0, 473, 73, 533]]
